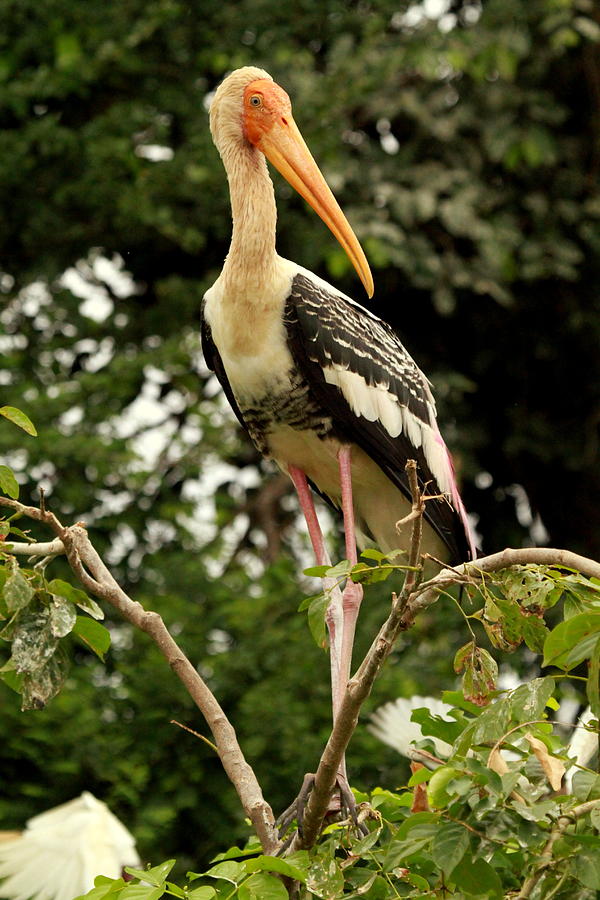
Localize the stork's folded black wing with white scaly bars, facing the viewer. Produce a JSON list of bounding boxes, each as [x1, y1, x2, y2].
[[285, 274, 471, 563]]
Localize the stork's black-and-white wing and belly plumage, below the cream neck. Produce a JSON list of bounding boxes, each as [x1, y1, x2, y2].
[[202, 261, 472, 563]]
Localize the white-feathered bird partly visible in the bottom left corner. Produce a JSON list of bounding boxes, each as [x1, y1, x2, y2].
[[0, 791, 140, 900]]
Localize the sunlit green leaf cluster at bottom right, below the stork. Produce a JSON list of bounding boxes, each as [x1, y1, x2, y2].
[[78, 677, 600, 900]]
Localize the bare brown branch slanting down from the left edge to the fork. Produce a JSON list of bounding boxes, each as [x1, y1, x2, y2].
[[0, 497, 280, 854]]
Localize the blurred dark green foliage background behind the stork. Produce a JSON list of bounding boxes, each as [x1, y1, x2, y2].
[[0, 0, 600, 872]]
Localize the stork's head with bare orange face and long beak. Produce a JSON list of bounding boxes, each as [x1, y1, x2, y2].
[[210, 66, 373, 297]]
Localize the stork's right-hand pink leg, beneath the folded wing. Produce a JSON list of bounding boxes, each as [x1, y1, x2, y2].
[[338, 447, 363, 703]]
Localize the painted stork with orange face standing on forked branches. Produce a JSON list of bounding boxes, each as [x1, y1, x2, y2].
[[202, 66, 474, 824]]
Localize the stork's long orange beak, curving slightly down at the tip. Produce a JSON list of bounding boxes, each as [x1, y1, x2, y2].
[[257, 113, 373, 297]]
